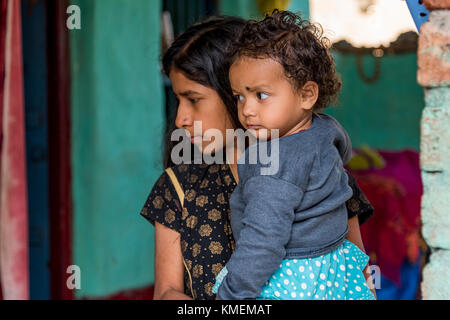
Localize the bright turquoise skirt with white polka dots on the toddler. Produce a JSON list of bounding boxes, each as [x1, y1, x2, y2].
[[213, 240, 375, 300]]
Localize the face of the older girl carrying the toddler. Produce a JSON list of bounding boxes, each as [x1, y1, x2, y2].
[[169, 68, 234, 153]]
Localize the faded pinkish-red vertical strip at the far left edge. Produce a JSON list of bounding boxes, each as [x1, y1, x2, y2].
[[0, 0, 29, 300]]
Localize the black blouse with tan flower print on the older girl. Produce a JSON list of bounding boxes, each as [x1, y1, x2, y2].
[[141, 164, 373, 300]]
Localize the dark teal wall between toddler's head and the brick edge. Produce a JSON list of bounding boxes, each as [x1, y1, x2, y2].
[[326, 53, 425, 150]]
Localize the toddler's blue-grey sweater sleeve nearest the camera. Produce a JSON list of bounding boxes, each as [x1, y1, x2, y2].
[[217, 176, 304, 300]]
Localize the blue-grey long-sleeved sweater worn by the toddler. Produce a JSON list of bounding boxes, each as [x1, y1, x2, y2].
[[217, 114, 352, 299]]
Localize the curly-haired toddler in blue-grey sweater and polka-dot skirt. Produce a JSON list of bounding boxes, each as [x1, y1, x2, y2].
[[213, 11, 374, 299]]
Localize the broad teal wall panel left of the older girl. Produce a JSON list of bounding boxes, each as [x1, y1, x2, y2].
[[70, 0, 164, 297]]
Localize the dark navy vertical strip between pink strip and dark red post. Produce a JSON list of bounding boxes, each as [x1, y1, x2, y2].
[[22, 1, 50, 299]]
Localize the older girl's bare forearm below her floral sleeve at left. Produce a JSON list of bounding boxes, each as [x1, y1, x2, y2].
[[153, 222, 192, 300]]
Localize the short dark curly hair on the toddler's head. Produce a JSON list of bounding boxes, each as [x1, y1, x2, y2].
[[232, 9, 342, 110]]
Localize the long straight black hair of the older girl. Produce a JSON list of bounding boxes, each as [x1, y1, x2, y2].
[[162, 16, 246, 168]]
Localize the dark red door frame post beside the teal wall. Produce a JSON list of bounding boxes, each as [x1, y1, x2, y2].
[[47, 0, 74, 300]]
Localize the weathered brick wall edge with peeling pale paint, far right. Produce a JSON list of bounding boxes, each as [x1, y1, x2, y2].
[[417, 0, 450, 299]]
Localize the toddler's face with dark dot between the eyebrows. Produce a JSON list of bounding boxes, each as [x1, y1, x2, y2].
[[229, 57, 312, 139]]
